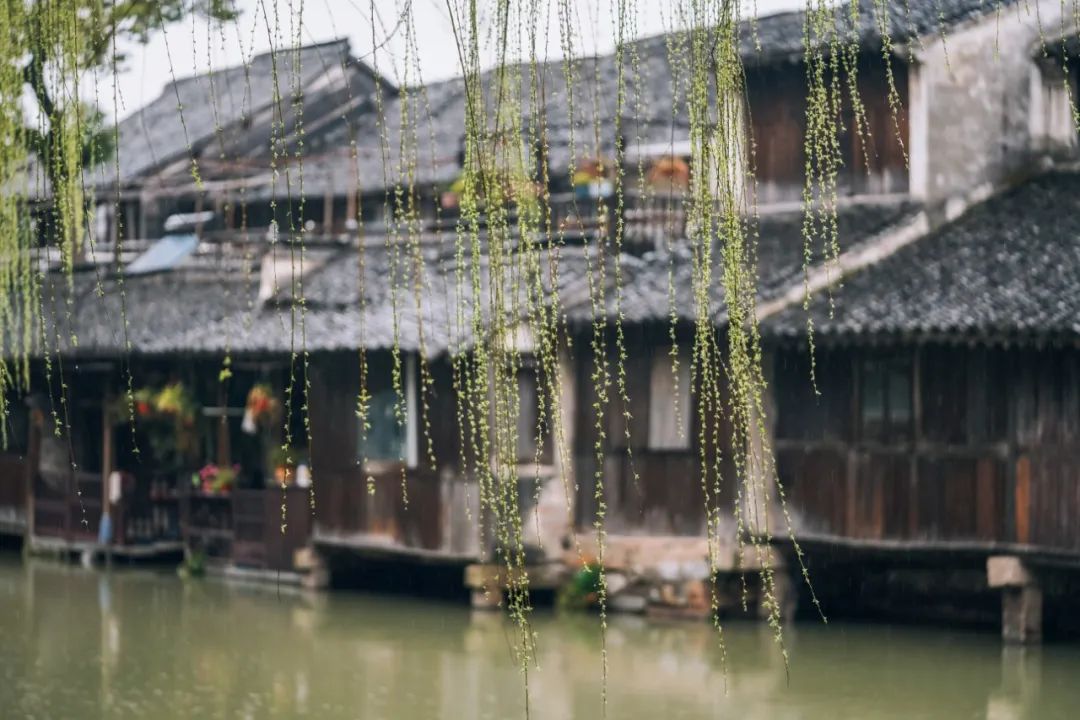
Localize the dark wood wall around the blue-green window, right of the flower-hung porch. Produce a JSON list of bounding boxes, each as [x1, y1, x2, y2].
[[310, 352, 475, 554]]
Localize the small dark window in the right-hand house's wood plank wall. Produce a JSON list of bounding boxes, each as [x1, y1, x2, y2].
[[859, 357, 913, 443]]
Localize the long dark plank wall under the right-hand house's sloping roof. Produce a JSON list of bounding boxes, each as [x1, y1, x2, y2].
[[773, 345, 1080, 552]]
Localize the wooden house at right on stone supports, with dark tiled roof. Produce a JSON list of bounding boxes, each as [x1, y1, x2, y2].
[[762, 173, 1080, 637]]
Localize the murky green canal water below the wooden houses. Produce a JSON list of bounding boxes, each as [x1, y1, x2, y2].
[[0, 556, 1080, 720]]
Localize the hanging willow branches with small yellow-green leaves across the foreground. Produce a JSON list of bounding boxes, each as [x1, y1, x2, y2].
[[0, 0, 1080, 716]]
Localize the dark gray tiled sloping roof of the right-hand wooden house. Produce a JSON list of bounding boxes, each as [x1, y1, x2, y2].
[[761, 173, 1080, 340]]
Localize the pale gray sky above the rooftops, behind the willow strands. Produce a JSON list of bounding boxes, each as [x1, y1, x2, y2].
[[105, 0, 807, 117]]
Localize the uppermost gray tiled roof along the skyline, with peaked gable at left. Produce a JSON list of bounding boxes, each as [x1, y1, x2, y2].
[[103, 0, 1016, 200]]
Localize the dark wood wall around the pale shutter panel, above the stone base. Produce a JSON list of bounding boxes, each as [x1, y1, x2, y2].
[[573, 325, 734, 535]]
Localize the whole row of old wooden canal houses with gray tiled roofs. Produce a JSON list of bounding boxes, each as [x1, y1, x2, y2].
[[10, 0, 1078, 634]]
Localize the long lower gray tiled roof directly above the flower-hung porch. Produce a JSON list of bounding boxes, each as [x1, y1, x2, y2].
[[23, 189, 912, 362]]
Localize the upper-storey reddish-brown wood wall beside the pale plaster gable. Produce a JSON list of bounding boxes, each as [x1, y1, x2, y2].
[[746, 55, 908, 203]]
